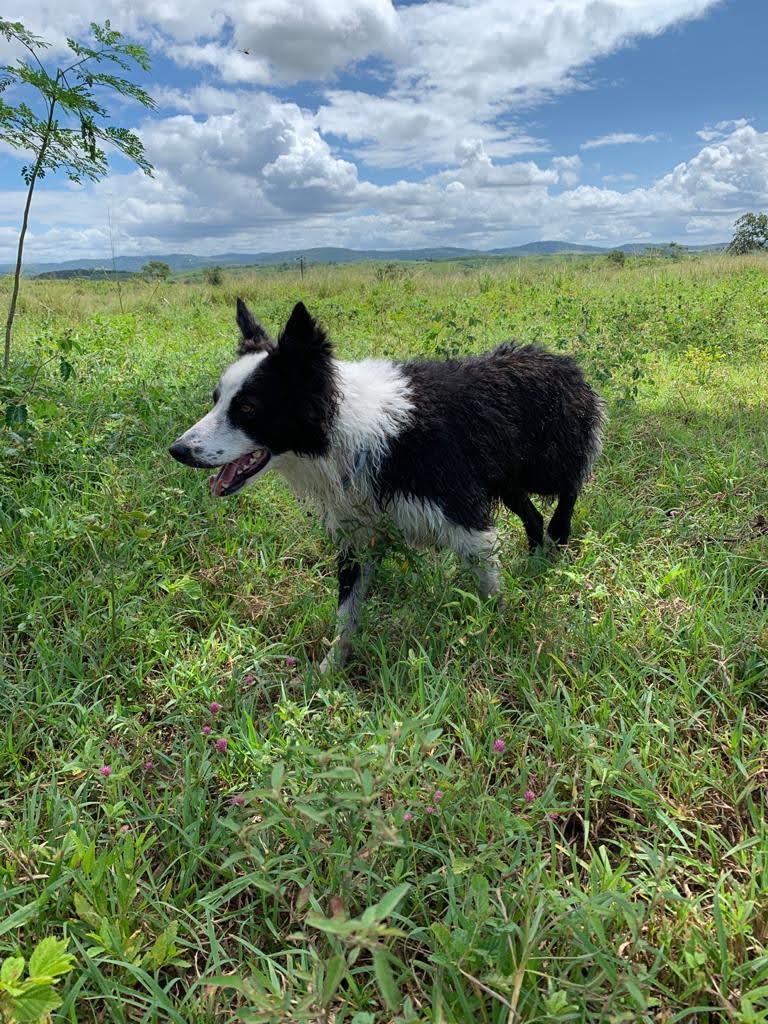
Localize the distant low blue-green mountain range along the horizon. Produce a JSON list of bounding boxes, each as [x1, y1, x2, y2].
[[6, 242, 726, 275]]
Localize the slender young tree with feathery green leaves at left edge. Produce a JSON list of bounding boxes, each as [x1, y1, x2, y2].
[[0, 18, 156, 370]]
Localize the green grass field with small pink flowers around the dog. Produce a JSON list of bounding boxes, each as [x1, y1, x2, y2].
[[0, 257, 768, 1024]]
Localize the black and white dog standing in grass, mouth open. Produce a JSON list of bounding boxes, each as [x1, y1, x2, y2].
[[170, 299, 604, 670]]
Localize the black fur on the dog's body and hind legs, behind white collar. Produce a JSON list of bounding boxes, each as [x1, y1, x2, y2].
[[378, 342, 602, 547]]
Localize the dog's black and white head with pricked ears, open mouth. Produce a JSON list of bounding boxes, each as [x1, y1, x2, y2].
[[170, 299, 337, 498]]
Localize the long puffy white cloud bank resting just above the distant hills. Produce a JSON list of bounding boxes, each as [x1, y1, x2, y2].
[[9, 121, 768, 260]]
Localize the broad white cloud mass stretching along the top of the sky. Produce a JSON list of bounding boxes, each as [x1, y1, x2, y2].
[[9, 0, 721, 168]]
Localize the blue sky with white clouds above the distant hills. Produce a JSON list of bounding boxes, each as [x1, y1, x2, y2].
[[0, 0, 768, 262]]
